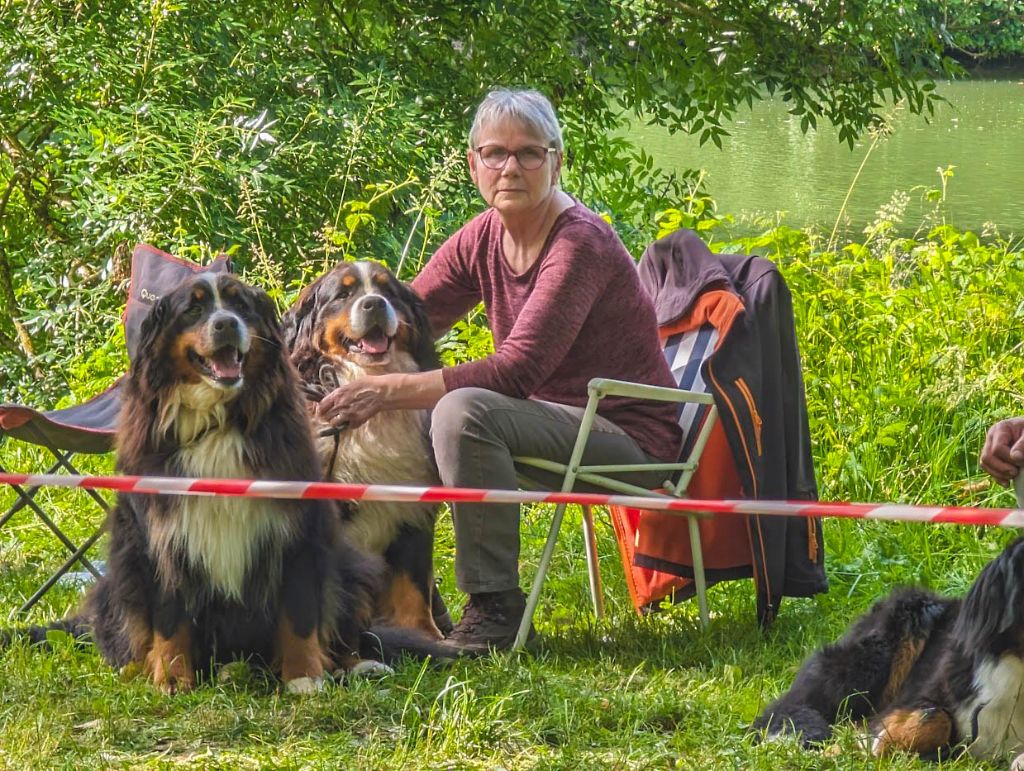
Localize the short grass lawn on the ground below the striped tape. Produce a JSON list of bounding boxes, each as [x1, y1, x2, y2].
[[0, 462, 1012, 769]]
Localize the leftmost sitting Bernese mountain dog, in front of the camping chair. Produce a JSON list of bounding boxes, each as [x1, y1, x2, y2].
[[6, 273, 448, 692]]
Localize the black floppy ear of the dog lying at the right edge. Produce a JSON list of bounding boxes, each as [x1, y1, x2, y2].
[[953, 539, 1024, 655]]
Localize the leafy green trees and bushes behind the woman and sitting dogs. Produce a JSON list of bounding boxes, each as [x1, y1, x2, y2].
[[0, 0, 953, 404]]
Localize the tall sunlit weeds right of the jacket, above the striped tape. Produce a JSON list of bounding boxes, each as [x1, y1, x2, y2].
[[659, 176, 1024, 505]]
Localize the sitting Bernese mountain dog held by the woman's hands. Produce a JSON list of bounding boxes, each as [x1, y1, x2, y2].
[[283, 261, 451, 639]]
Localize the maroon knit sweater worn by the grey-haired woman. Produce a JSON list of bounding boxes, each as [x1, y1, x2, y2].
[[413, 202, 682, 461]]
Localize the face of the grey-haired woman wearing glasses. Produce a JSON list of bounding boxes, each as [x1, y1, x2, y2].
[[468, 120, 562, 216]]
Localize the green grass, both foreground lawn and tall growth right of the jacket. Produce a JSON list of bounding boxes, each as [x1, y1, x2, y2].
[[0, 219, 1024, 769]]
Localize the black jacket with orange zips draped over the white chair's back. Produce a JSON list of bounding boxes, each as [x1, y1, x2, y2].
[[639, 230, 828, 626]]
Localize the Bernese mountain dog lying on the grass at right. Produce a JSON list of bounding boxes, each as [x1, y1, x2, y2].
[[753, 539, 1024, 760]]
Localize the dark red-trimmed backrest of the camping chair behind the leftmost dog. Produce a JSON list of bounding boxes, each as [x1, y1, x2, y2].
[[122, 244, 231, 359]]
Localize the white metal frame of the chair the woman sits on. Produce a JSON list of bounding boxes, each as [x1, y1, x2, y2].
[[512, 378, 718, 649]]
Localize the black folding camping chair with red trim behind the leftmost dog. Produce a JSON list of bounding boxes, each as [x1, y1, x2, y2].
[[0, 244, 230, 612]]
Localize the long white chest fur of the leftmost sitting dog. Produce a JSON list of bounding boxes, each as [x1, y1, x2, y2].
[[152, 384, 292, 601]]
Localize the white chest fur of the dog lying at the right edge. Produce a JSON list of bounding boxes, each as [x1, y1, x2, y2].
[[955, 653, 1024, 759]]
